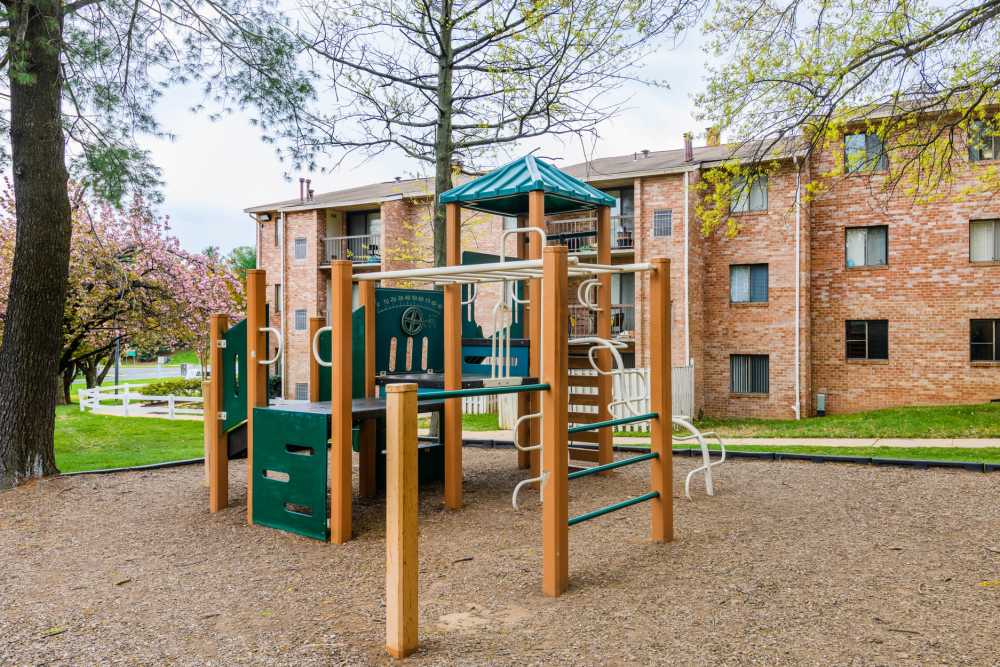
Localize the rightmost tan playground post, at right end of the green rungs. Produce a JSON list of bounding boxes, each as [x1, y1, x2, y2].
[[649, 257, 674, 542]]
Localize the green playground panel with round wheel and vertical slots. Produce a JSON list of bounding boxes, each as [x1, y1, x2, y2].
[[375, 287, 444, 373]]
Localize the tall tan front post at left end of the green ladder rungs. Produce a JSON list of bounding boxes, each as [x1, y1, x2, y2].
[[541, 245, 569, 597]]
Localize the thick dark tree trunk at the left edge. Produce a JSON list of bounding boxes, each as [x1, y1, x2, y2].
[[0, 0, 72, 489]]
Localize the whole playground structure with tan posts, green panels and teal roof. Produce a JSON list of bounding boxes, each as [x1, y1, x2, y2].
[[205, 156, 721, 656]]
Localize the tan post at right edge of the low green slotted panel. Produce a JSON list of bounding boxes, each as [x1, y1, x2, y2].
[[330, 259, 354, 544]]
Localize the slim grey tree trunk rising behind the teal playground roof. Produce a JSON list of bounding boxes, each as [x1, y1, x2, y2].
[[434, 2, 454, 266]]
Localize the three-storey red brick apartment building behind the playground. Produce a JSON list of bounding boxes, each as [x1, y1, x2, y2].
[[247, 133, 1000, 418]]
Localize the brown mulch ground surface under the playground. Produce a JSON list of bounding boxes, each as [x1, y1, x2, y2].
[[0, 449, 1000, 665]]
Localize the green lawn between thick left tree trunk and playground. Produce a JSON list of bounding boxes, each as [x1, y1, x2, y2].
[[55, 405, 204, 472]]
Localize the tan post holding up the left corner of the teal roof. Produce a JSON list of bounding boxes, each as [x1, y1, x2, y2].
[[443, 203, 463, 509]]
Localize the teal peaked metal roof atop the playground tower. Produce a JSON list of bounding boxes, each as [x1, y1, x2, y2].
[[441, 155, 615, 216]]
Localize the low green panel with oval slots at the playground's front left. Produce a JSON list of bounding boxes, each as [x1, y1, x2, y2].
[[253, 408, 329, 540]]
